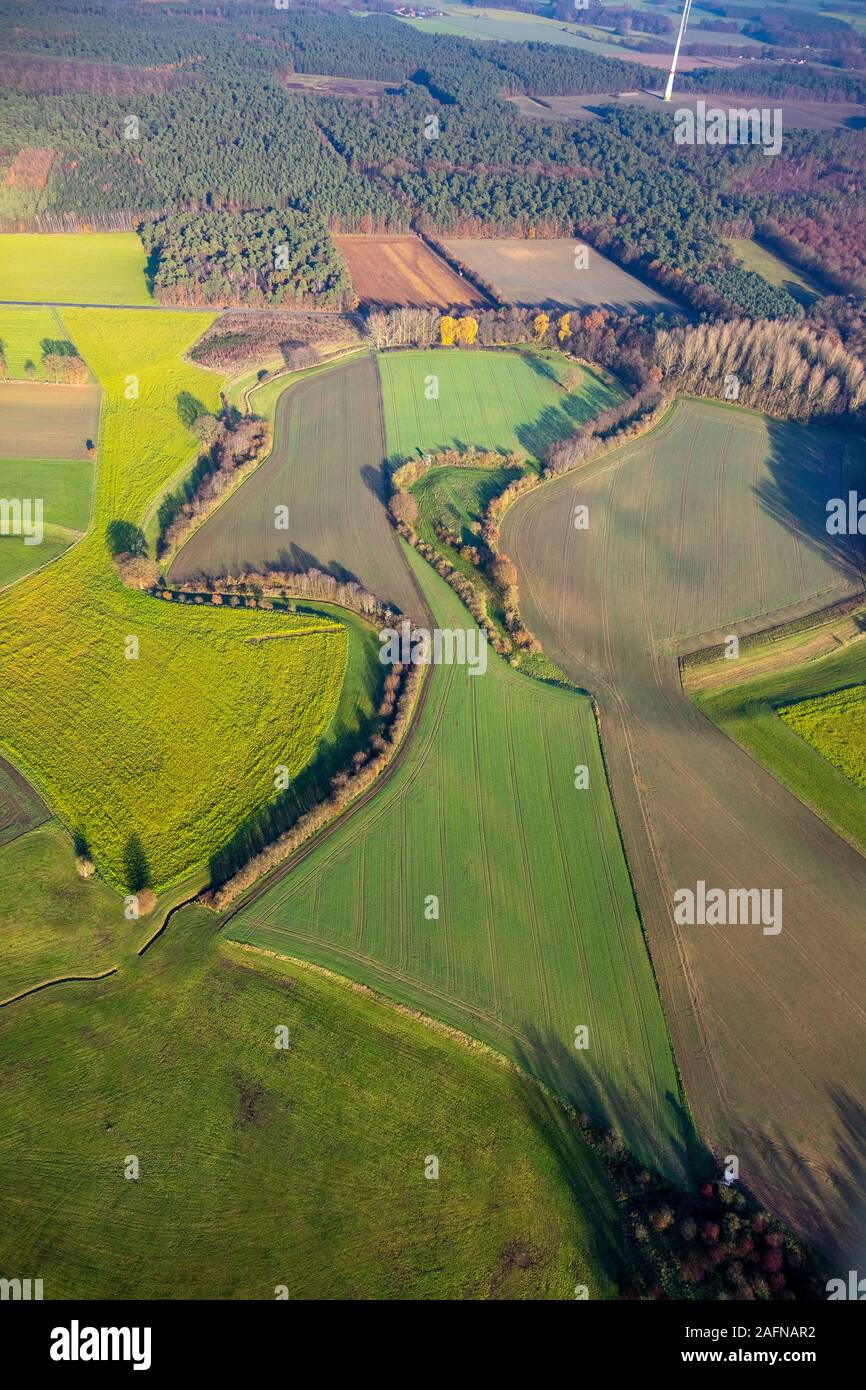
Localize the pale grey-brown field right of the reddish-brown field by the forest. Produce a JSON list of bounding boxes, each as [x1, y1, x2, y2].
[[445, 236, 677, 313]]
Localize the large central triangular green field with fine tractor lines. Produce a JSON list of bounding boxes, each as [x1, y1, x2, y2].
[[227, 552, 684, 1170]]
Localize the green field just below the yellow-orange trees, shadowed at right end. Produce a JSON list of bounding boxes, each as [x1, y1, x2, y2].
[[378, 349, 617, 460]]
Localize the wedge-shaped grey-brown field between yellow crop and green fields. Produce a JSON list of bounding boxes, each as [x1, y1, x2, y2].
[[171, 357, 418, 612]]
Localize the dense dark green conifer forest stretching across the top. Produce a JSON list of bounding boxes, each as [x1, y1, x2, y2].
[[0, 0, 866, 318]]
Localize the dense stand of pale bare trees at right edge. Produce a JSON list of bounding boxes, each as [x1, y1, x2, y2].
[[655, 320, 866, 420]]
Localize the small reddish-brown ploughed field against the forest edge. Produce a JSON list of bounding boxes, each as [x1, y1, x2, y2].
[[334, 235, 485, 309]]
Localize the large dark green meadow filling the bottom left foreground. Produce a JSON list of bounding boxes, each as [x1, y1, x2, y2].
[[0, 889, 628, 1300]]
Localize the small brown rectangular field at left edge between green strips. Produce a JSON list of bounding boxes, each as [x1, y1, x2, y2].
[[0, 381, 100, 459]]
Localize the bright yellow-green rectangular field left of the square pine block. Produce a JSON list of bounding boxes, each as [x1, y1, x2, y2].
[[0, 232, 152, 304]]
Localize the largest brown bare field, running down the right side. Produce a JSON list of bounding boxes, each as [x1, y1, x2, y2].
[[503, 402, 866, 1269]]
